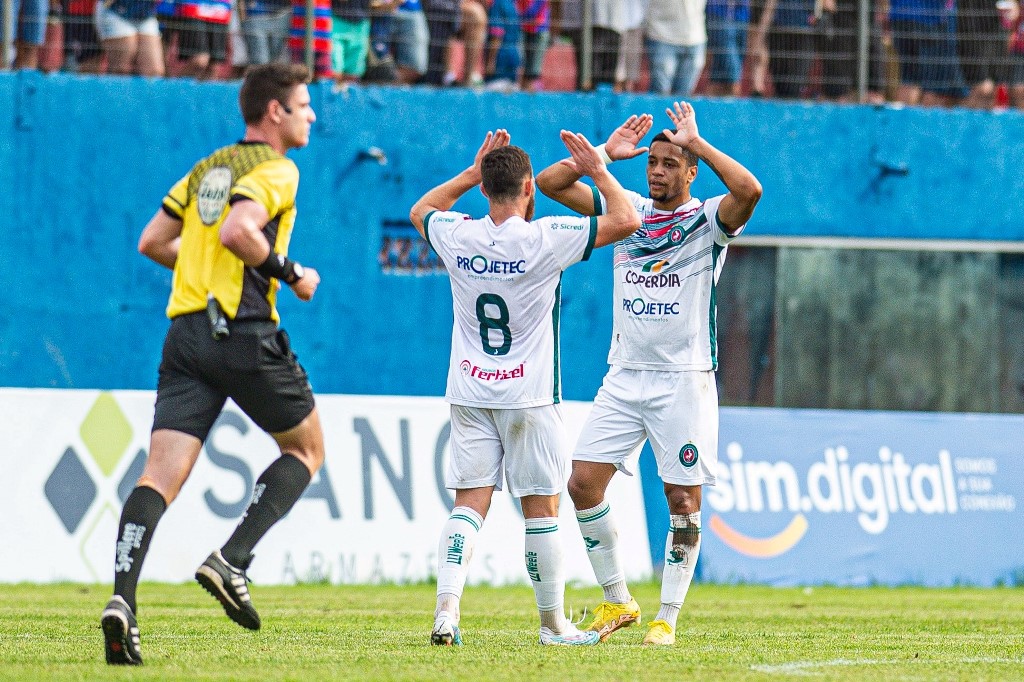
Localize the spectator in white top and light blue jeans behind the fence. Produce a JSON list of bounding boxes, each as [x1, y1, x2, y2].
[[646, 0, 708, 97]]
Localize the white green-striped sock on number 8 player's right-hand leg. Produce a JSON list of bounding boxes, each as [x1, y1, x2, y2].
[[526, 518, 566, 634]]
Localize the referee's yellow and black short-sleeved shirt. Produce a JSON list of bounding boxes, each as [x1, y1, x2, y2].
[[157, 142, 299, 323]]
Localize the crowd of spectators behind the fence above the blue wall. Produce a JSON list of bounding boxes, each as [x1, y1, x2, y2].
[[2, 0, 1024, 109]]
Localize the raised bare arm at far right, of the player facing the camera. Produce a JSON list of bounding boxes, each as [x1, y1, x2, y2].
[[664, 101, 762, 233]]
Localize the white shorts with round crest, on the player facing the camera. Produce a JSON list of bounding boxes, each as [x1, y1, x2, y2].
[[572, 366, 718, 485]]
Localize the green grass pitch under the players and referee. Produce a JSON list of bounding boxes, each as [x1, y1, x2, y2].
[[0, 584, 1024, 682]]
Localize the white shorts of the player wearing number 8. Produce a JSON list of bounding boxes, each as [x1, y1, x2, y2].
[[444, 404, 568, 498]]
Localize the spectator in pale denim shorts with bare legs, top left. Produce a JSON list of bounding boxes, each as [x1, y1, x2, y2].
[[93, 0, 164, 76]]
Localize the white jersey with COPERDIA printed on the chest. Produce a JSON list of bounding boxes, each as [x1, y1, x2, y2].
[[595, 189, 742, 371]]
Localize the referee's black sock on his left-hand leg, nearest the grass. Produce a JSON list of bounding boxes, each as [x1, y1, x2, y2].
[[114, 485, 167, 613]]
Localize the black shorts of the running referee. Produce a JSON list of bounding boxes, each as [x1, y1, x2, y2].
[[153, 311, 315, 440]]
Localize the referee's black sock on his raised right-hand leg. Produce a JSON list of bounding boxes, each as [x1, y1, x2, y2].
[[220, 453, 312, 569]]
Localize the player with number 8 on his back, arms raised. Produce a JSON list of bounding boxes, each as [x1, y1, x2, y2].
[[410, 125, 640, 645]]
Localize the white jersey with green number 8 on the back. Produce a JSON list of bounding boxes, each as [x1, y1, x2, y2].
[[423, 211, 597, 409]]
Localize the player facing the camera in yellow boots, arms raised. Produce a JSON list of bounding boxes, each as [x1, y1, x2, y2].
[[537, 102, 761, 644]]
